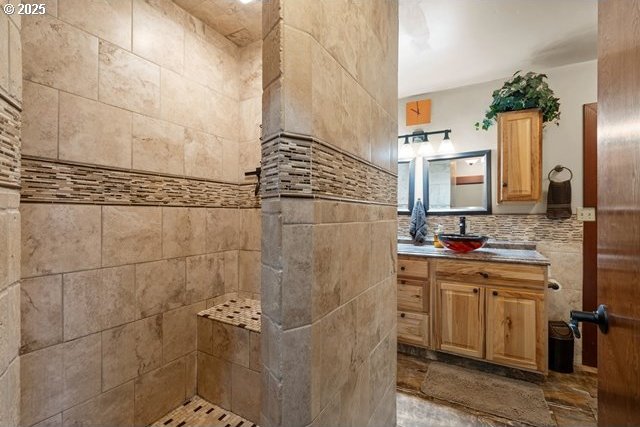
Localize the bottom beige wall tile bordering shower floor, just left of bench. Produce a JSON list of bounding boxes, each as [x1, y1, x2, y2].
[[135, 359, 186, 425]]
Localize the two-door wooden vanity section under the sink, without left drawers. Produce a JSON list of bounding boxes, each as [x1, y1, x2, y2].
[[434, 260, 547, 372]]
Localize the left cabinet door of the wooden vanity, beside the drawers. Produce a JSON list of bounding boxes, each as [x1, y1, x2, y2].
[[437, 281, 484, 357]]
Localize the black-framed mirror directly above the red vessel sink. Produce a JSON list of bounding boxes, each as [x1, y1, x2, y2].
[[423, 150, 491, 215]]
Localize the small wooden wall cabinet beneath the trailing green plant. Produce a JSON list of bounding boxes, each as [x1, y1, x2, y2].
[[498, 109, 542, 203]]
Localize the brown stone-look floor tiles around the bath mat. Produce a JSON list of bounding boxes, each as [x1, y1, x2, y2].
[[397, 353, 597, 427]]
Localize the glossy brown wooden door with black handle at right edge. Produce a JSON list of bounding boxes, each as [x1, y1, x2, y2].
[[598, 0, 640, 426]]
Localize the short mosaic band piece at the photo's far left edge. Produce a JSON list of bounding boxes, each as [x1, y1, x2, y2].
[[0, 96, 21, 189]]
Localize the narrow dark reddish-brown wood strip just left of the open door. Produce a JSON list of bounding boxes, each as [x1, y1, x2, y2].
[[582, 103, 598, 367]]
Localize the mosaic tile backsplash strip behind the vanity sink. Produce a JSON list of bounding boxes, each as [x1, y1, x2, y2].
[[398, 214, 583, 243]]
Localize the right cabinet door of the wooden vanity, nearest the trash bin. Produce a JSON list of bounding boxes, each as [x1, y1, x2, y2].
[[487, 288, 546, 371]]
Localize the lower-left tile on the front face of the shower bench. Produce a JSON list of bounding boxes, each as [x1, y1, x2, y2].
[[198, 351, 232, 408]]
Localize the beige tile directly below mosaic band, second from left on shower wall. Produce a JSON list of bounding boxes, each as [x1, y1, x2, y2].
[[102, 206, 162, 266]]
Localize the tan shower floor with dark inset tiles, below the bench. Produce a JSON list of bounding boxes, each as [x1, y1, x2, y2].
[[151, 396, 257, 427]]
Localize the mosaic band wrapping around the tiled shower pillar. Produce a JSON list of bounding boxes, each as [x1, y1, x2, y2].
[[261, 133, 397, 205]]
